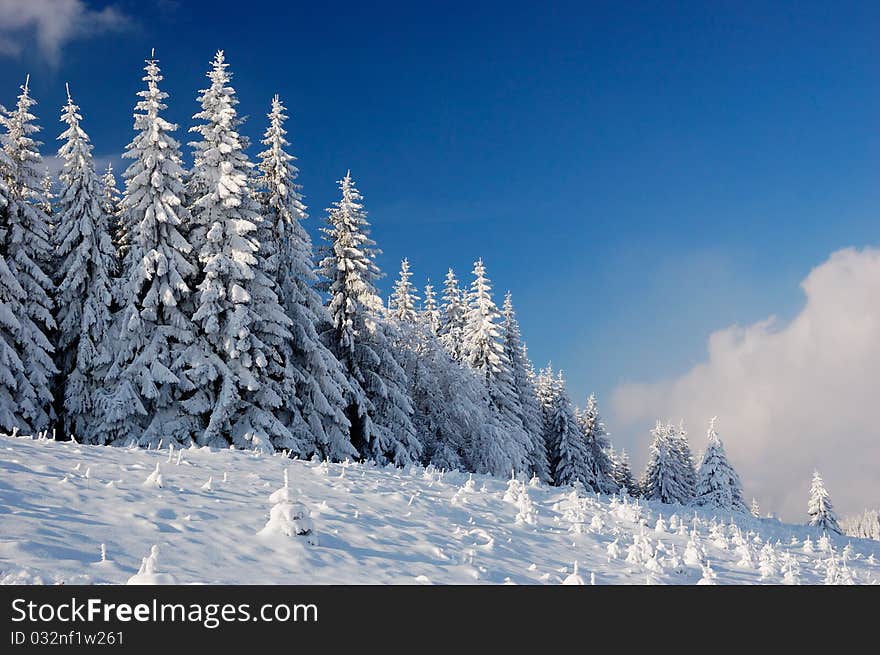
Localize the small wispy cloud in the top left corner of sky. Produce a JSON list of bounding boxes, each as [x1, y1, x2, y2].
[[0, 0, 129, 64]]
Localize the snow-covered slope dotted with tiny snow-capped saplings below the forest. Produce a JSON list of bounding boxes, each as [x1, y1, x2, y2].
[[0, 437, 880, 584]]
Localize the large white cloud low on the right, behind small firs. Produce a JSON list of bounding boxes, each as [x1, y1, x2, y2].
[[612, 248, 880, 521]]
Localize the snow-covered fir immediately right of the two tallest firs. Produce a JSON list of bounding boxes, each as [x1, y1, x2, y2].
[[259, 96, 357, 461]]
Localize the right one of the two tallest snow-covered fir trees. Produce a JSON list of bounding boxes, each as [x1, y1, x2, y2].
[[188, 50, 296, 452]]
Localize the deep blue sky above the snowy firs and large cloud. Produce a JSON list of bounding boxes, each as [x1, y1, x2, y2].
[[0, 0, 880, 466]]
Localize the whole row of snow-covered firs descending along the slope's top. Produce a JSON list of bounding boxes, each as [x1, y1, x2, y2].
[[0, 51, 868, 538]]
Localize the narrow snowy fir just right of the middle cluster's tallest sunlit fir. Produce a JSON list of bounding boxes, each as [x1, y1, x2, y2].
[[503, 292, 551, 482]]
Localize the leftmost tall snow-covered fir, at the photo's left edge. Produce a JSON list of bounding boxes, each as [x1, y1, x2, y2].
[[0, 80, 57, 432]]
